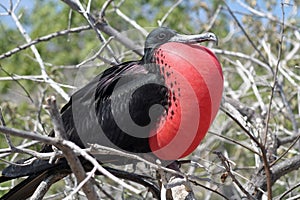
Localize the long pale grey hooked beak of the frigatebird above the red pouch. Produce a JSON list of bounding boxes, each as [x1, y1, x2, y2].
[[169, 32, 218, 45]]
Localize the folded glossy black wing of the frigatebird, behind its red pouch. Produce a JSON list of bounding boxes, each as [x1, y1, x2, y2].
[[62, 61, 167, 152]]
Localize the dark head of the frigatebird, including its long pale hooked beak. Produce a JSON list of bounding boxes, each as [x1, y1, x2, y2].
[[144, 27, 218, 61]]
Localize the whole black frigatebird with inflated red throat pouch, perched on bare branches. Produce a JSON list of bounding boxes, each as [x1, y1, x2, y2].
[[0, 27, 223, 200]]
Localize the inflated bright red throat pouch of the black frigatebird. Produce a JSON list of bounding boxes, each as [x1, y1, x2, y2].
[[149, 42, 223, 160]]
